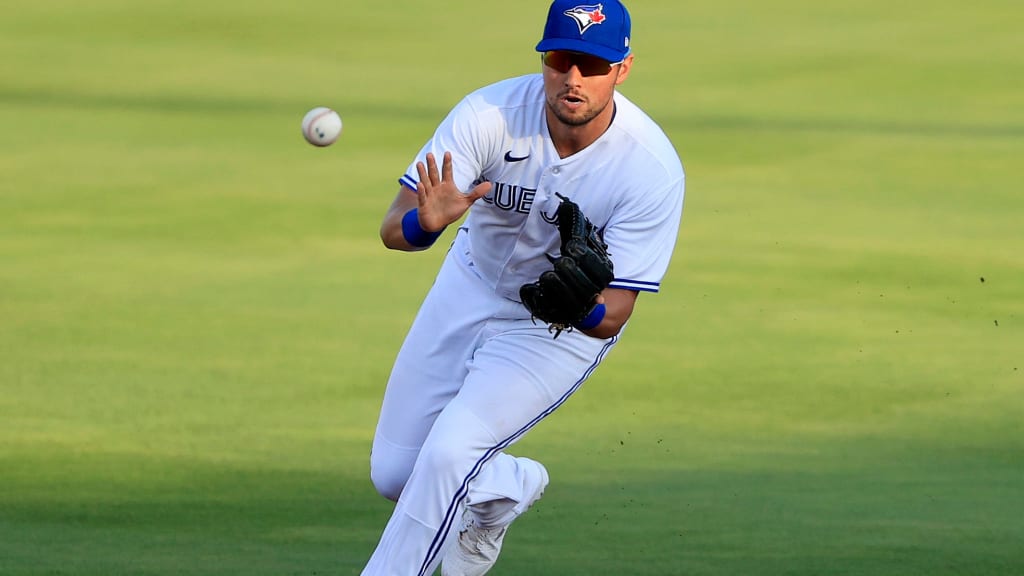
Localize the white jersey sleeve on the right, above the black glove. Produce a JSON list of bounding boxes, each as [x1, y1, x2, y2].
[[604, 175, 686, 292]]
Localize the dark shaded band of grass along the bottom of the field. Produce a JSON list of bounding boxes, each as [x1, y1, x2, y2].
[[0, 440, 1024, 576]]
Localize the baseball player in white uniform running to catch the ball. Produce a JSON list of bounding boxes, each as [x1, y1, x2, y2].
[[362, 0, 684, 576]]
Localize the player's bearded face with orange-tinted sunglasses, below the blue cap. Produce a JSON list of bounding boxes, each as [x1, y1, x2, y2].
[[542, 50, 633, 126]]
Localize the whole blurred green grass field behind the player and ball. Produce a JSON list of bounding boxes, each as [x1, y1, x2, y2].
[[0, 0, 1024, 576]]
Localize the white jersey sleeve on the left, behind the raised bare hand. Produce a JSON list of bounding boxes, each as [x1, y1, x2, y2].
[[398, 94, 496, 192]]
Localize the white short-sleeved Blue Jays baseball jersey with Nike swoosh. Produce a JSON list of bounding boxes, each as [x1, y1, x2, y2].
[[399, 74, 685, 300]]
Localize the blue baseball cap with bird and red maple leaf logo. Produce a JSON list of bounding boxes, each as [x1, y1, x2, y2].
[[537, 0, 630, 63]]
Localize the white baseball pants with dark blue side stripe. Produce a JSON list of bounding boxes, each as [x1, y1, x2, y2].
[[362, 231, 617, 576]]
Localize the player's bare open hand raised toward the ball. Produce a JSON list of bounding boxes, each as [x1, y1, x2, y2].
[[416, 152, 490, 232]]
